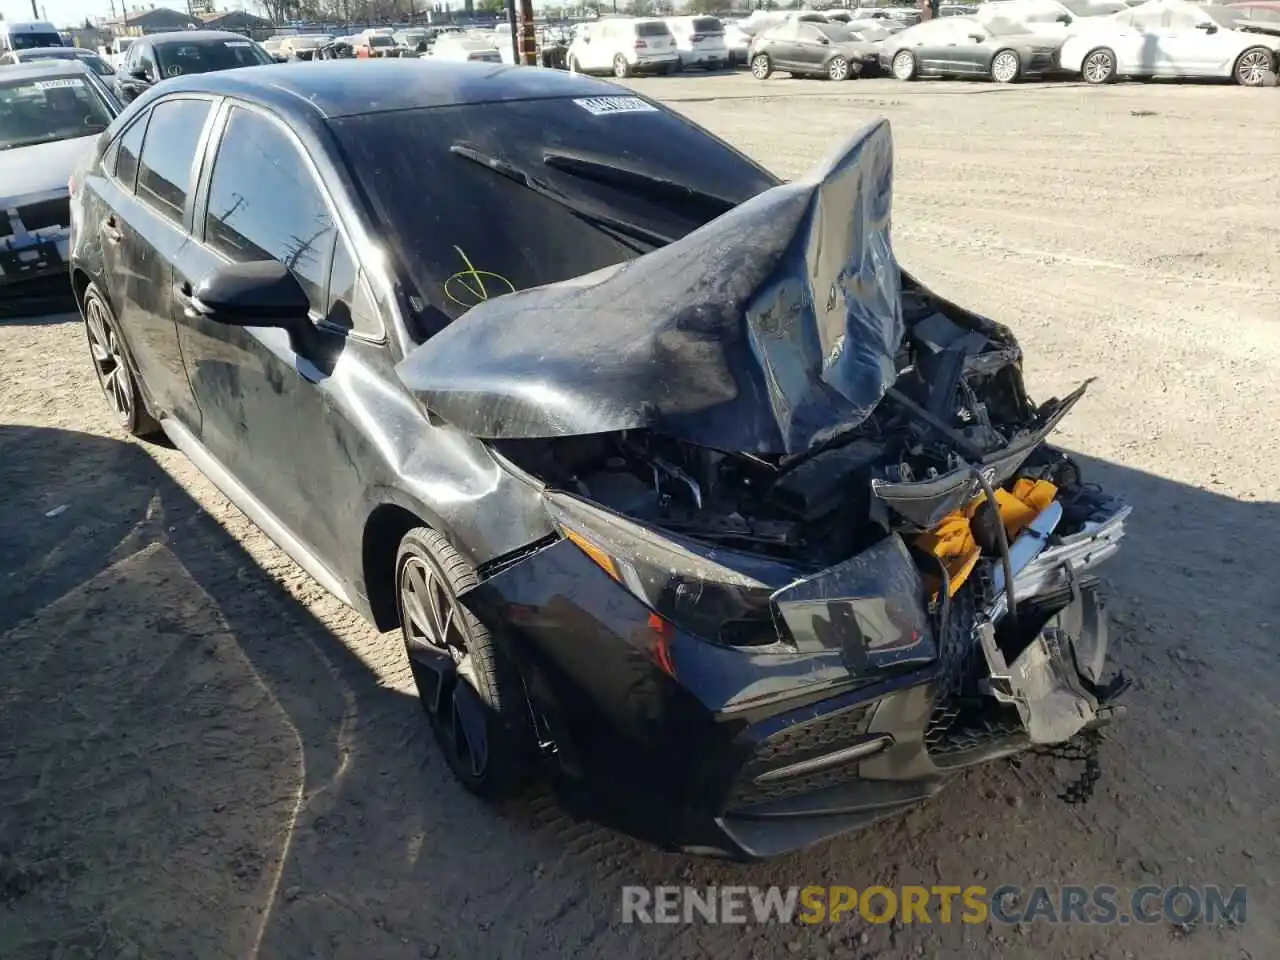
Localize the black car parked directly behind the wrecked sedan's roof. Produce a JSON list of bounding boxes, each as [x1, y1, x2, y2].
[[115, 29, 271, 104]]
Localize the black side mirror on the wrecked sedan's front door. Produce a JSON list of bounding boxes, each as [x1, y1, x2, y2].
[[184, 260, 311, 330]]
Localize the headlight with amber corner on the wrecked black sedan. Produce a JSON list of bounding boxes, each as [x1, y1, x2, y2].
[[547, 492, 795, 646]]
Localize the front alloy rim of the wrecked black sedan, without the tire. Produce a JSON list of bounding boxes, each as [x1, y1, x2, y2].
[[399, 557, 489, 778]]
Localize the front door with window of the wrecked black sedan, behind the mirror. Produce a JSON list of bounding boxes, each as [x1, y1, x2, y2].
[[174, 104, 392, 564]]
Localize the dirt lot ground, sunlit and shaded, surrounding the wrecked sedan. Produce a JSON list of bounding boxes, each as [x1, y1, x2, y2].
[[0, 76, 1280, 960]]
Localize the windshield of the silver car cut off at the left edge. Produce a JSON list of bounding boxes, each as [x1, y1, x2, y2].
[[0, 77, 111, 150]]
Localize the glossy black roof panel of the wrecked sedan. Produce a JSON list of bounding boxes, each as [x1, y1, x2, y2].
[[156, 58, 645, 119]]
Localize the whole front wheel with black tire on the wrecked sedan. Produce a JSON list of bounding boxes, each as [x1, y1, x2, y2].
[[396, 526, 534, 800]]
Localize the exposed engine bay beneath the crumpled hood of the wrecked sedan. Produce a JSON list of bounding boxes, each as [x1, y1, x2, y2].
[[497, 281, 1092, 593]]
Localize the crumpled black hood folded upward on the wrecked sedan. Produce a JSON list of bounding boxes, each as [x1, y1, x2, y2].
[[397, 120, 904, 454]]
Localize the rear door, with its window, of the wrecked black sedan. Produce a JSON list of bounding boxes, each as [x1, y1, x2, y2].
[[99, 96, 212, 428]]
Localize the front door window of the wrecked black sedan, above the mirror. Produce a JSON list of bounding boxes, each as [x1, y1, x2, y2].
[[205, 108, 338, 314]]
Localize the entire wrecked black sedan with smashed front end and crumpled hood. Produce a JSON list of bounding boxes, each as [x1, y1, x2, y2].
[[73, 61, 1129, 858]]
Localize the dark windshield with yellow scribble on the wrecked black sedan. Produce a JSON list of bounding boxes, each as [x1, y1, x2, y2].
[[330, 96, 773, 337]]
